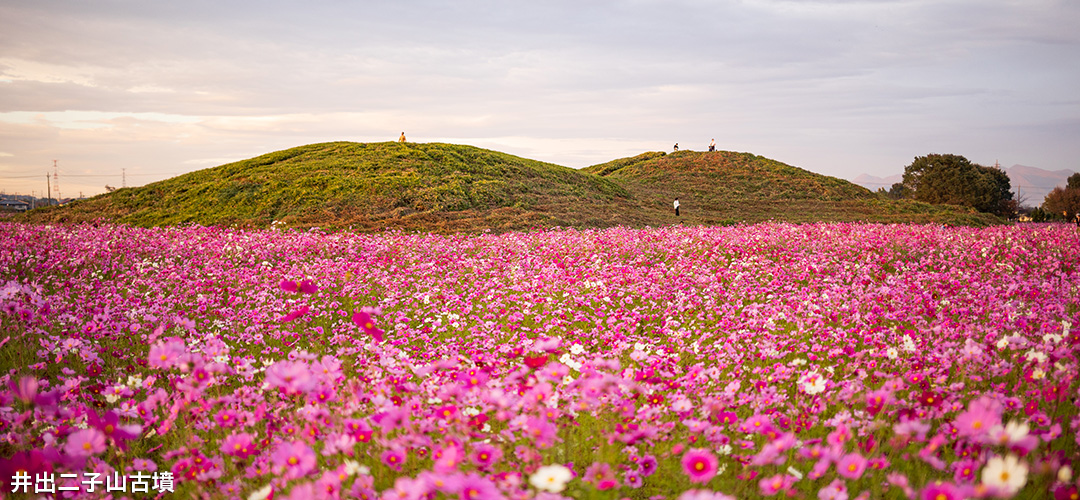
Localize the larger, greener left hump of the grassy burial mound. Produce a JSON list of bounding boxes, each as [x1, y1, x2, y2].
[[21, 143, 635, 232]]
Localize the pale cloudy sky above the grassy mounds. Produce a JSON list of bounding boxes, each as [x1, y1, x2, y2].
[[0, 0, 1080, 198]]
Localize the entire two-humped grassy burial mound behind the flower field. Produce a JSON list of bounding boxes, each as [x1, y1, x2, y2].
[[16, 143, 998, 232]]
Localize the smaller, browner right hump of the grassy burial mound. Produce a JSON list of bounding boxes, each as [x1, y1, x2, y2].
[[582, 151, 1000, 226]]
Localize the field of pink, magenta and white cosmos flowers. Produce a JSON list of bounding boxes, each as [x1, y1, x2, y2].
[[0, 224, 1080, 500]]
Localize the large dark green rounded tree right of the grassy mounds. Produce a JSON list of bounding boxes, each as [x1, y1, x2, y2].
[[893, 154, 1016, 216]]
